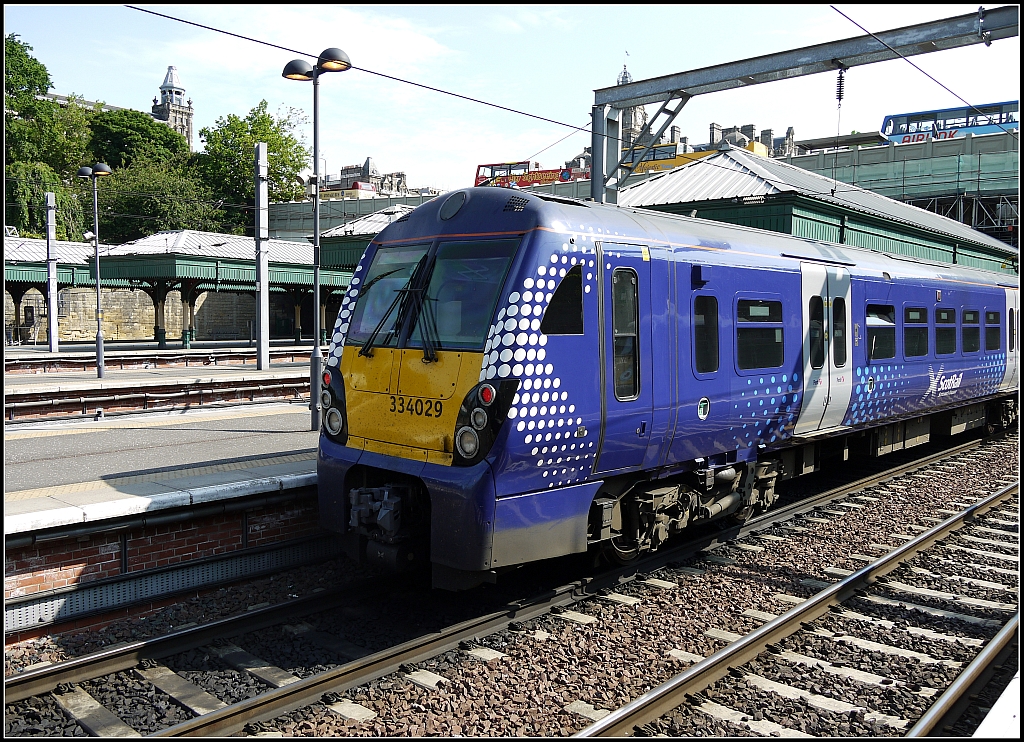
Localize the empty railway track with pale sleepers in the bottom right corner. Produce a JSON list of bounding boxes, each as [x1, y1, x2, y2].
[[578, 483, 1020, 737]]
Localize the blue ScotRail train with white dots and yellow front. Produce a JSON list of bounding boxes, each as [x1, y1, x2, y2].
[[317, 188, 1020, 590]]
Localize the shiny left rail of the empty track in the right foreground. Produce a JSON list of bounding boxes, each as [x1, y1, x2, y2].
[[573, 482, 1020, 737]]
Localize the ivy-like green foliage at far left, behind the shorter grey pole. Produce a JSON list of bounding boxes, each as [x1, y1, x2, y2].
[[4, 163, 84, 241]]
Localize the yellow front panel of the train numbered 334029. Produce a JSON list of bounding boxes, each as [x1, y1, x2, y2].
[[341, 346, 483, 465]]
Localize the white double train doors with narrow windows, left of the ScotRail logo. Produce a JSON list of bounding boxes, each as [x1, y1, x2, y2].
[[794, 263, 853, 435]]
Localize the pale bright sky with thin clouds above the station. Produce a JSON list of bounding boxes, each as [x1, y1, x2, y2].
[[4, 4, 1020, 190]]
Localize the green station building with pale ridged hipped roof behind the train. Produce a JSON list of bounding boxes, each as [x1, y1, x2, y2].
[[618, 146, 1020, 273]]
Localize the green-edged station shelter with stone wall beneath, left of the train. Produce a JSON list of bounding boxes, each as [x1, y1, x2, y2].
[[4, 229, 352, 348]]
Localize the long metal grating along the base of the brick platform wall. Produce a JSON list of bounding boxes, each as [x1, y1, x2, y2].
[[4, 536, 341, 634]]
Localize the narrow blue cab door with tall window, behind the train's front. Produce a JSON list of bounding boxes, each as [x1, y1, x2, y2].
[[598, 243, 653, 472]]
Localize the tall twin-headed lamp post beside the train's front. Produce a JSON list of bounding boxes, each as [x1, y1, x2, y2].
[[282, 48, 352, 430]]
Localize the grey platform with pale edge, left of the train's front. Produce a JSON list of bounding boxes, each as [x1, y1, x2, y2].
[[4, 403, 318, 538]]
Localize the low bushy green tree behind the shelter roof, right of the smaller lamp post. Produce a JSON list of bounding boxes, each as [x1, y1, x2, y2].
[[92, 154, 225, 245]]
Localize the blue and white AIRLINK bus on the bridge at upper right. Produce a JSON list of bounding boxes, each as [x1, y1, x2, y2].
[[882, 100, 1020, 144]]
